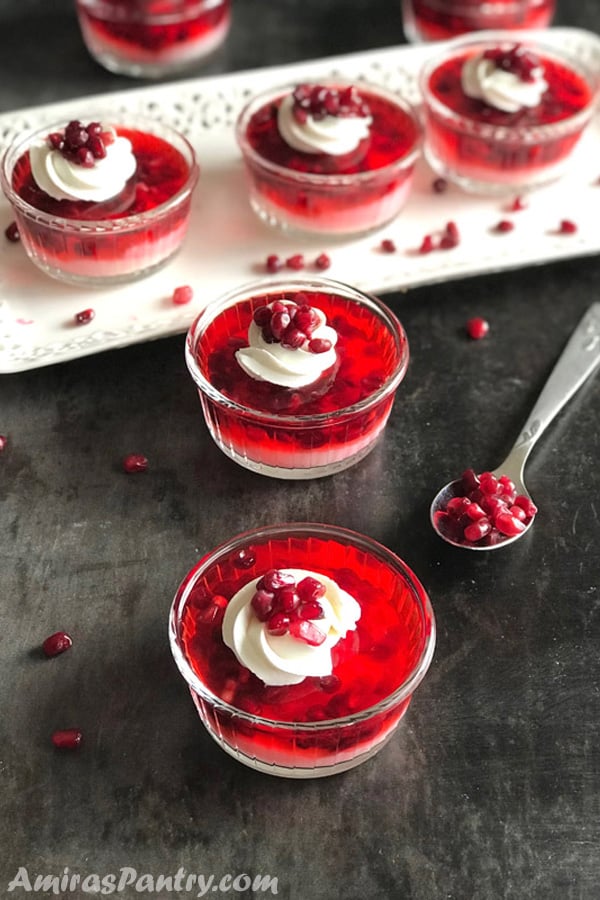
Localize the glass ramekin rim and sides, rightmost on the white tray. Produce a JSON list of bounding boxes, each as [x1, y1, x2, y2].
[[419, 30, 598, 195]]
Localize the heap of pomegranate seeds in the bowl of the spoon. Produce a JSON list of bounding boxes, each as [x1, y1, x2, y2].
[[436, 469, 537, 546]]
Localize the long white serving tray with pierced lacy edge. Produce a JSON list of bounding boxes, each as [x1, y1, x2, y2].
[[0, 28, 600, 374]]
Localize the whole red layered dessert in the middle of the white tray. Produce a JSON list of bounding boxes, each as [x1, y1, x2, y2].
[[236, 82, 421, 237]]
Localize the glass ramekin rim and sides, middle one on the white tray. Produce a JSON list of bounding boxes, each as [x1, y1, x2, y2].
[[235, 79, 421, 239]]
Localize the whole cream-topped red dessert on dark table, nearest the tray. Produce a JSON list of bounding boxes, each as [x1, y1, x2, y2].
[[186, 279, 409, 479]]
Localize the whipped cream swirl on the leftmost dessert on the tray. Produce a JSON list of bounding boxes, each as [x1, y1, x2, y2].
[[29, 126, 137, 203]]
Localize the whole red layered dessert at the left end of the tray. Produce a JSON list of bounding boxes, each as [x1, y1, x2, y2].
[[0, 116, 198, 287]]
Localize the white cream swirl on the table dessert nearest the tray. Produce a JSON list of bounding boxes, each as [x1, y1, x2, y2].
[[235, 303, 337, 388]]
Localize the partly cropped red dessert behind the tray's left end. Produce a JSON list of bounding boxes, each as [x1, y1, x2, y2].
[[76, 0, 231, 78]]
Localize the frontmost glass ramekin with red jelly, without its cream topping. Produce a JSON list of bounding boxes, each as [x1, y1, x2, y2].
[[169, 523, 435, 778]]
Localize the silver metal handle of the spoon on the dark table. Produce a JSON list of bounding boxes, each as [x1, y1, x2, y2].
[[499, 303, 600, 472]]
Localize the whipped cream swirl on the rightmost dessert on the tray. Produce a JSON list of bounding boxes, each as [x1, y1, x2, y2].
[[461, 50, 548, 113]]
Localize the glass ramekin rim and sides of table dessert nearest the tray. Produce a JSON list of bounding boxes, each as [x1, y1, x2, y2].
[[185, 278, 409, 479]]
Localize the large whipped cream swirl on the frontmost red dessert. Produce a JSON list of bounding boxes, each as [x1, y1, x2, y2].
[[222, 568, 361, 686]]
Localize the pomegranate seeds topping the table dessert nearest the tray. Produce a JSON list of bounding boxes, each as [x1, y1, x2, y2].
[[253, 293, 332, 353]]
